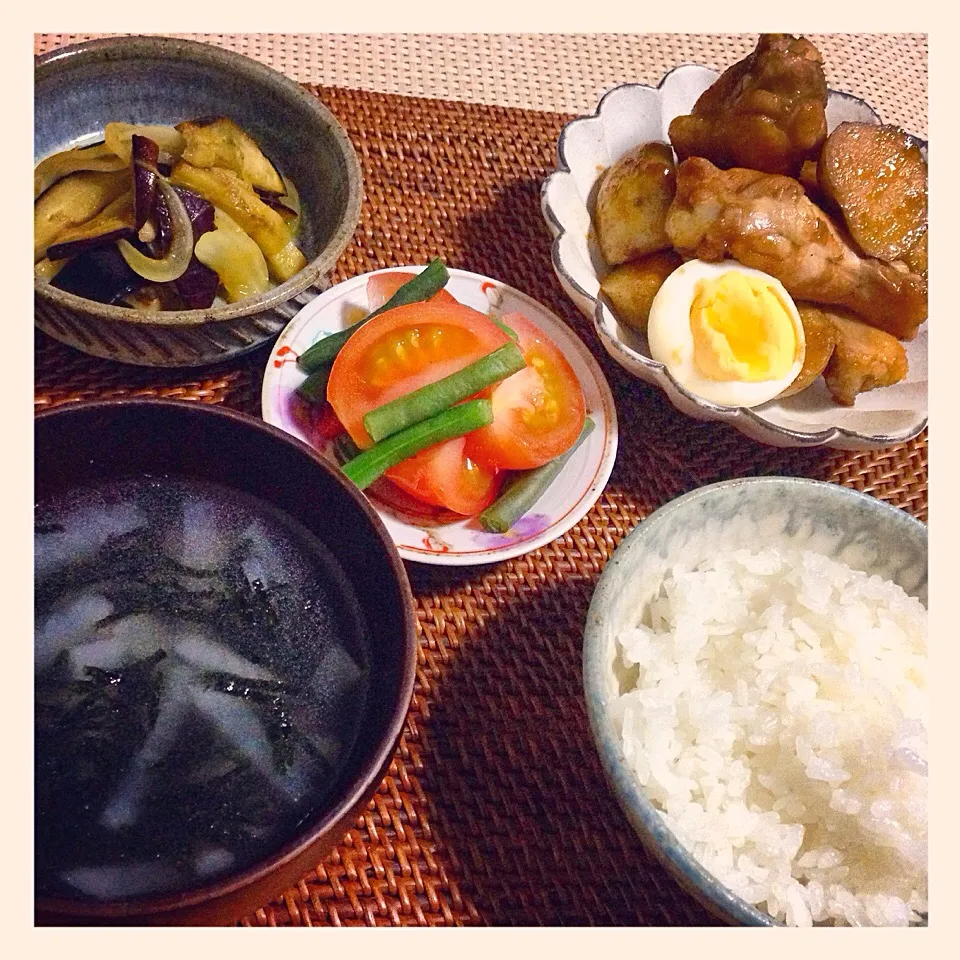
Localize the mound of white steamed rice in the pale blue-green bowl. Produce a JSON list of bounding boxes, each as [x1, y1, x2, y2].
[[615, 548, 927, 926]]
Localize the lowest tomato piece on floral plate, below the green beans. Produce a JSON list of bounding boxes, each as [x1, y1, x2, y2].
[[387, 437, 502, 517]]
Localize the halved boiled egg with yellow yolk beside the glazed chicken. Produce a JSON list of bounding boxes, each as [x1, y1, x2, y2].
[[647, 260, 805, 407]]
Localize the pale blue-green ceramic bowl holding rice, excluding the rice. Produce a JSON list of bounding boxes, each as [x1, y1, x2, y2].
[[583, 477, 927, 926]]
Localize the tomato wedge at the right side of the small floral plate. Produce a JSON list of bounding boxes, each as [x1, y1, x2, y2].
[[466, 313, 586, 470]]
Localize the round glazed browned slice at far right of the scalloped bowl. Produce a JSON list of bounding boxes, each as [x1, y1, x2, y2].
[[817, 123, 927, 261]]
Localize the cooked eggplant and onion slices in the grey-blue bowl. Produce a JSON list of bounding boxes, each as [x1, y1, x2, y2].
[[33, 117, 307, 310]]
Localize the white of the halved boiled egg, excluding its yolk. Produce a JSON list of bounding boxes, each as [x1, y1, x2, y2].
[[647, 260, 805, 407]]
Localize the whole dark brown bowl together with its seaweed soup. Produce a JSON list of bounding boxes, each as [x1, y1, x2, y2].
[[34, 400, 416, 925]]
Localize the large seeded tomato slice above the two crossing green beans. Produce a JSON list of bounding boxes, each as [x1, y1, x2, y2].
[[327, 300, 508, 447]]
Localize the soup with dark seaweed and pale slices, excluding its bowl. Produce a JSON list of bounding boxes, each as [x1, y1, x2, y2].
[[35, 478, 369, 899]]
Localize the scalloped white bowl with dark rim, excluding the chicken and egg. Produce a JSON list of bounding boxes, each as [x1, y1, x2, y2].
[[541, 65, 927, 450]]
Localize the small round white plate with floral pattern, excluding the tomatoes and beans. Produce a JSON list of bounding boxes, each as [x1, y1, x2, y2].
[[262, 267, 617, 566]]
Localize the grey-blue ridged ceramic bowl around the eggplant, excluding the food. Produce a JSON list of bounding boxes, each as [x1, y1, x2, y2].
[[34, 37, 363, 366]]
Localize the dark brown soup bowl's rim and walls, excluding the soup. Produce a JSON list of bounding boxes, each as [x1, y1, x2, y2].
[[35, 400, 416, 924]]
